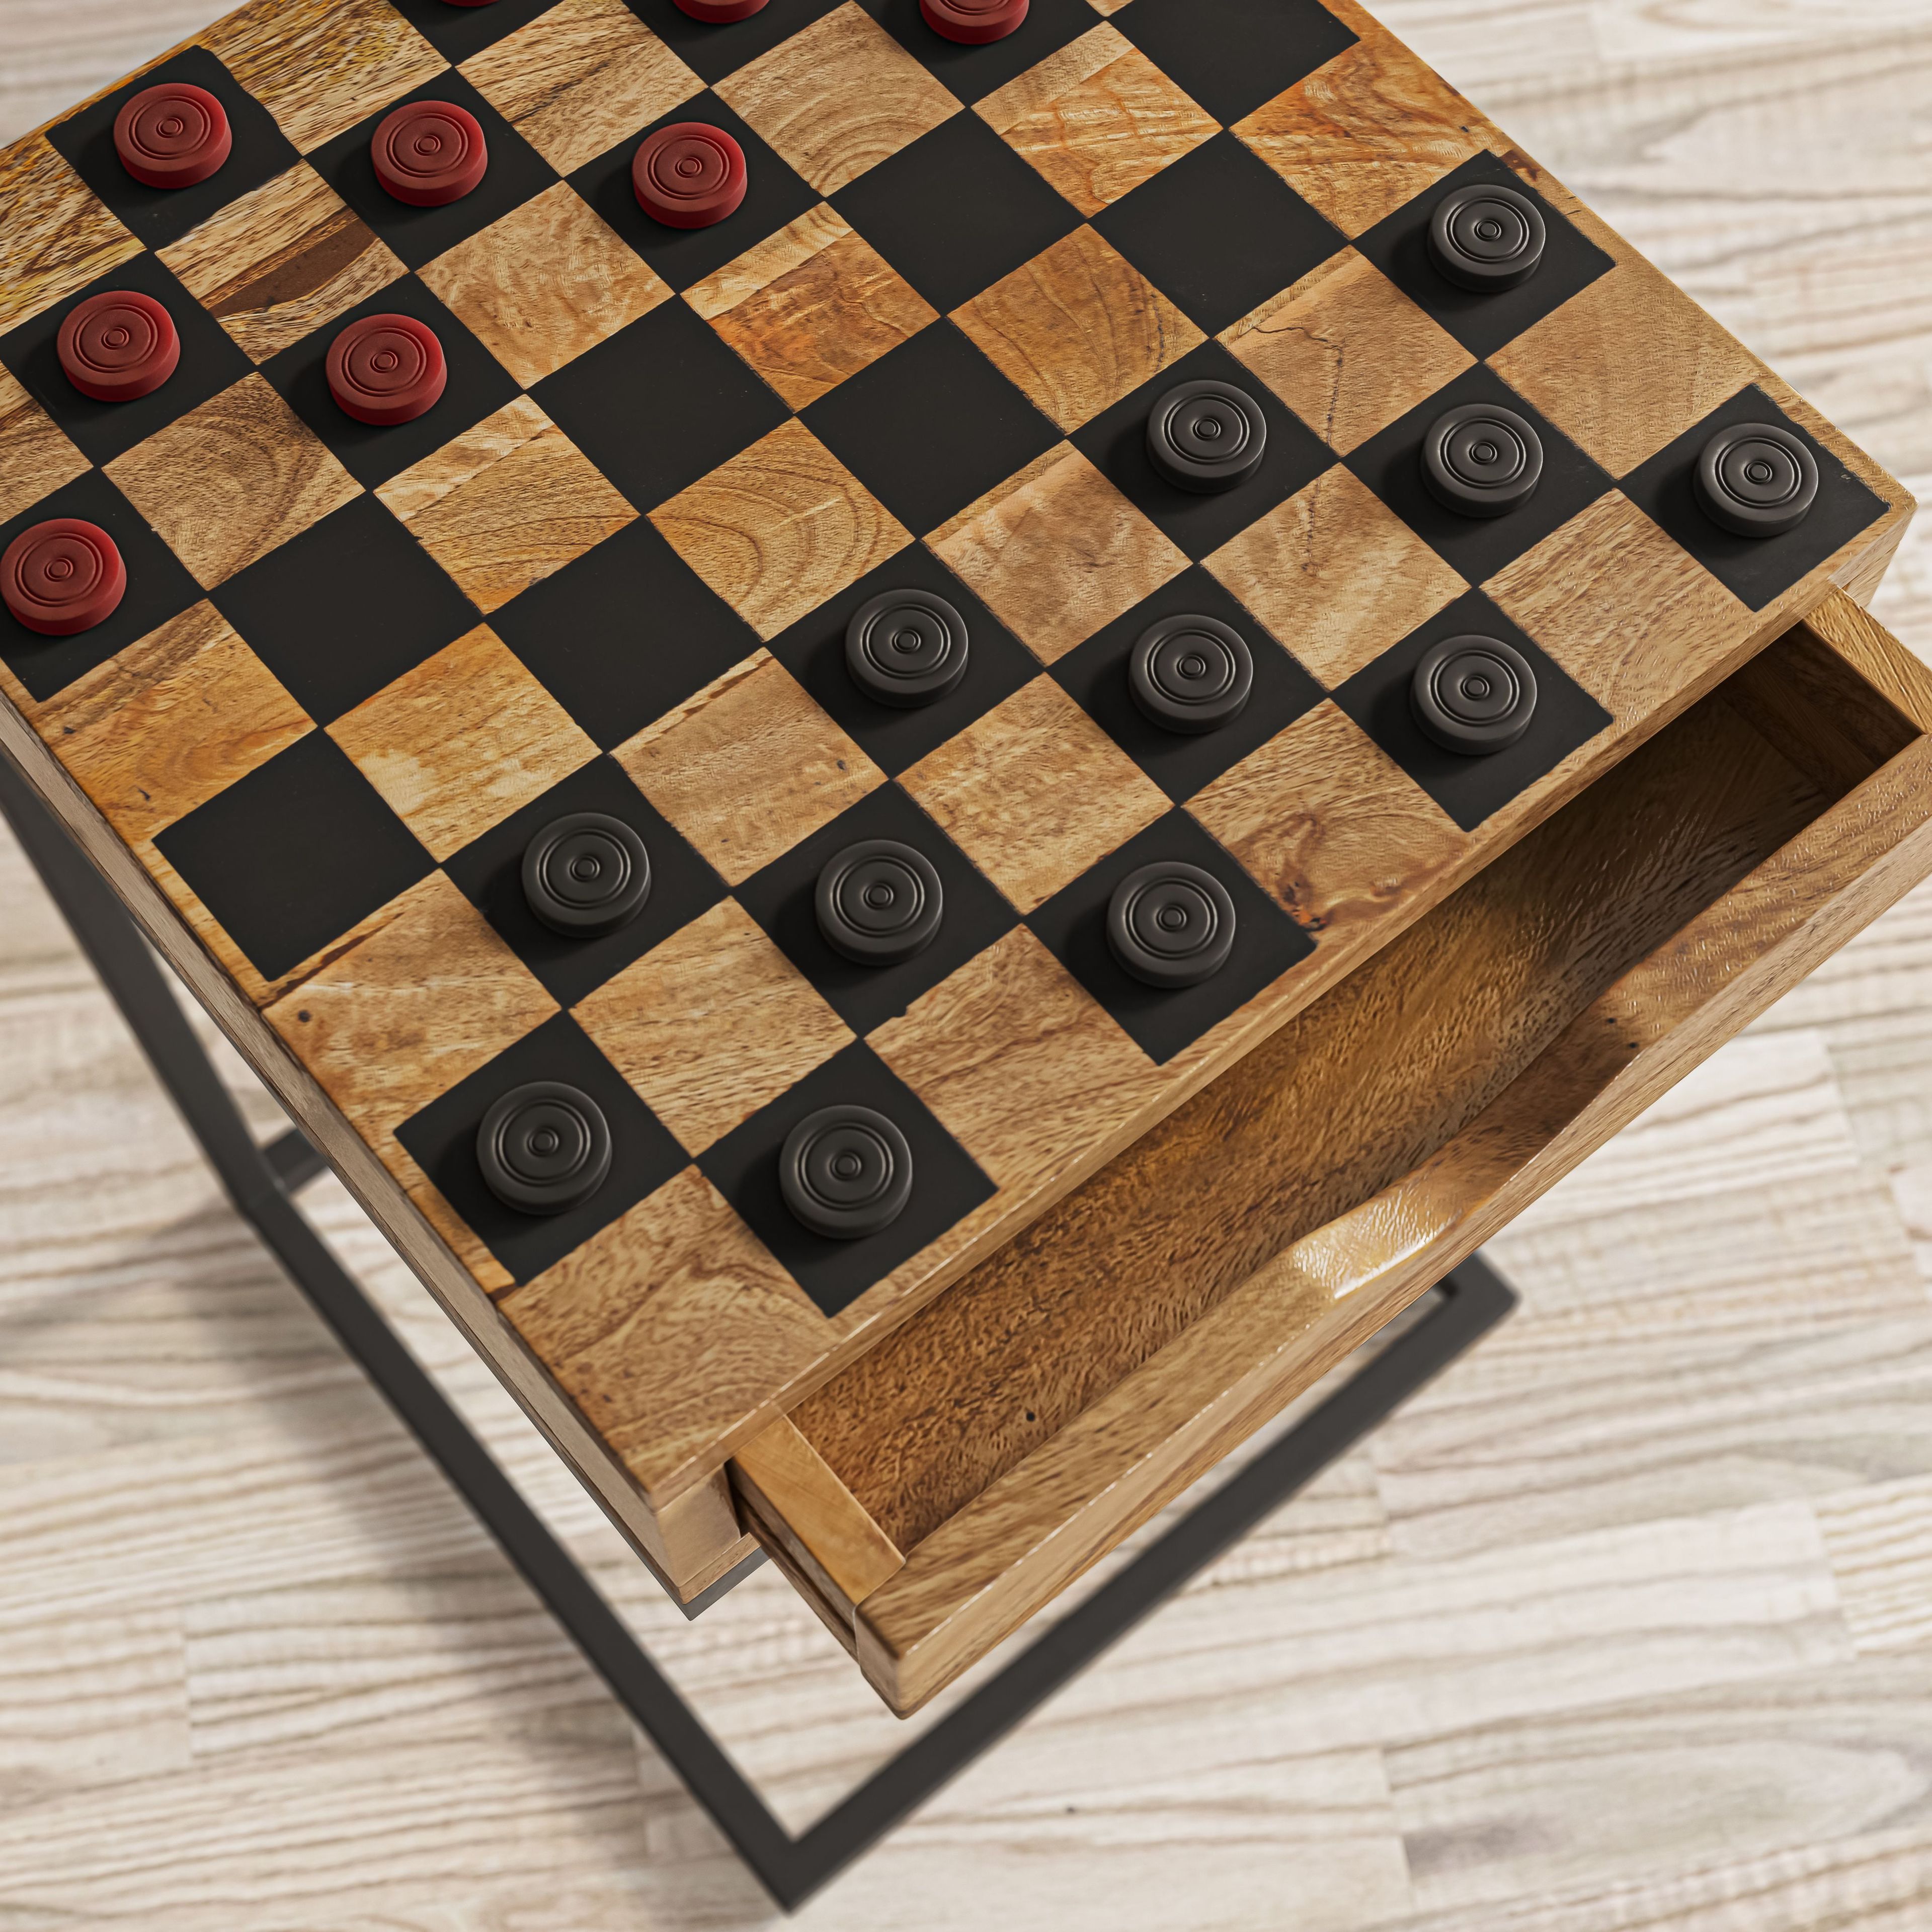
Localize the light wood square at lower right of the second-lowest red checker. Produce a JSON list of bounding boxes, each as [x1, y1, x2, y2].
[[377, 396, 637, 614]]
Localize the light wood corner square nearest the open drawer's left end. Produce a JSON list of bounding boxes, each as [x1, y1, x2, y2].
[[499, 1167, 827, 1501]]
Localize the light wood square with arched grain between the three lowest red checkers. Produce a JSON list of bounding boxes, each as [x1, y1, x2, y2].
[[106, 375, 361, 589]]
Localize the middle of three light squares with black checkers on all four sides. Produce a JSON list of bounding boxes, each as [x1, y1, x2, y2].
[[900, 678, 1167, 912]]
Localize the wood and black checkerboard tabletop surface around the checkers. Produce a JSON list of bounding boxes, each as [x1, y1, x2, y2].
[[0, 0, 1895, 1491]]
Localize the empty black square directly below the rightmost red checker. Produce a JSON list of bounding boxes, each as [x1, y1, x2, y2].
[[833, 112, 1080, 315]]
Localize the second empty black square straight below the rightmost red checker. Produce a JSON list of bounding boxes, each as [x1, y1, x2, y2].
[[803, 320, 1061, 533]]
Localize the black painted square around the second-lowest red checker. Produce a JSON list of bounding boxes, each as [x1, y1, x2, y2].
[[261, 274, 518, 489]]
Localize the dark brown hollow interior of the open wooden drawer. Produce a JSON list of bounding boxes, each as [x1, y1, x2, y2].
[[738, 605, 1932, 1708]]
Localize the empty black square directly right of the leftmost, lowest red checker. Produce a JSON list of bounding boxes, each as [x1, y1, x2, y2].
[[209, 497, 479, 725]]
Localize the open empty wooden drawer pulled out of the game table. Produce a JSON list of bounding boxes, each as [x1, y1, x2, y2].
[[731, 595, 1932, 1714]]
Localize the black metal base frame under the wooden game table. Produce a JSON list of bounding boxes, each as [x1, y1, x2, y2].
[[0, 755, 1516, 1911]]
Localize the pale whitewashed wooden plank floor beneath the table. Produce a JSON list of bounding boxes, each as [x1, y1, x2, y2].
[[0, 0, 1932, 1932]]
